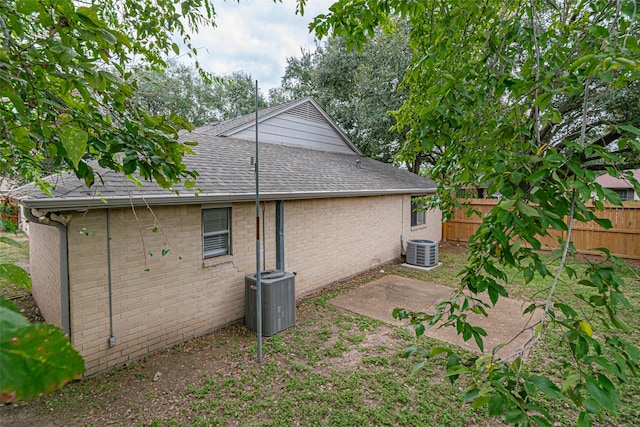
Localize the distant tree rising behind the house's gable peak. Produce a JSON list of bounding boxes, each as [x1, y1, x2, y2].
[[271, 22, 410, 166]]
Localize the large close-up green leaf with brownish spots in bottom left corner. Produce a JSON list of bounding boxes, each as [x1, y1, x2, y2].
[[0, 307, 84, 402]]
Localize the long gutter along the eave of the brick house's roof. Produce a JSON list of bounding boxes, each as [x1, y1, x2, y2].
[[20, 188, 435, 211]]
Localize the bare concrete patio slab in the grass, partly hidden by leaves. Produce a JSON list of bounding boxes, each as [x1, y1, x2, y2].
[[328, 275, 541, 357]]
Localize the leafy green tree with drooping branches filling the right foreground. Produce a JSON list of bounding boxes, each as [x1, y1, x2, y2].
[[312, 0, 640, 426]]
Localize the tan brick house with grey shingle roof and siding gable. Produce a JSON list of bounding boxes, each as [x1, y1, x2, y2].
[[14, 98, 442, 374]]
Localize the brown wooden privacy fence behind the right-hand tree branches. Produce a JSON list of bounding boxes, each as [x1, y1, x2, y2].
[[442, 199, 640, 259]]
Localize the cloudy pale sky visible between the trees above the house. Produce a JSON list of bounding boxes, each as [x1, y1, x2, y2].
[[185, 0, 334, 94]]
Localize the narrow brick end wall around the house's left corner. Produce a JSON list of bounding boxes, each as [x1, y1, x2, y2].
[[29, 223, 62, 327]]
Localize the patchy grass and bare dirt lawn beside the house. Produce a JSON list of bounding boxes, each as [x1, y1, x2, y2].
[[0, 244, 640, 426]]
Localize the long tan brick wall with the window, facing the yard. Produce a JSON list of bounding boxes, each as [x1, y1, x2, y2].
[[61, 196, 442, 374]]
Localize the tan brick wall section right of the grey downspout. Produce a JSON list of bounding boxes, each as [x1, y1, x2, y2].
[[285, 196, 442, 297]]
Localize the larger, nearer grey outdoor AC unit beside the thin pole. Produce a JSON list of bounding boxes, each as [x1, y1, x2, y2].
[[244, 270, 296, 337]]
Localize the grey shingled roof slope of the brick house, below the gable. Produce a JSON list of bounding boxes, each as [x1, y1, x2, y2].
[[12, 130, 435, 211]]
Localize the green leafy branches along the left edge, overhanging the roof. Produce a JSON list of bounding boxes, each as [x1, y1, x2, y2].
[[0, 0, 218, 402]]
